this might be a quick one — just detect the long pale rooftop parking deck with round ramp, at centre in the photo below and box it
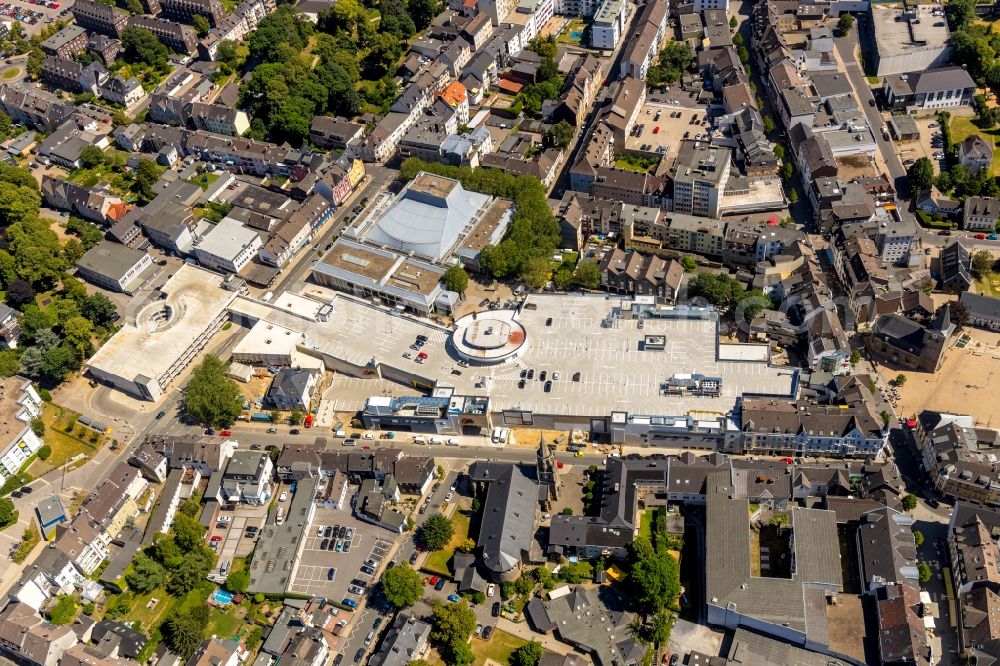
[233,287,795,416]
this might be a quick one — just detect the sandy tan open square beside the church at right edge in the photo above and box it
[879,328,1000,427]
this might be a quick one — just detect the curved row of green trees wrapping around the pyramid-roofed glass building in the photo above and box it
[400,157,560,288]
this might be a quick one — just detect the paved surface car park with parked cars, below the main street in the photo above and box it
[290,507,399,603]
